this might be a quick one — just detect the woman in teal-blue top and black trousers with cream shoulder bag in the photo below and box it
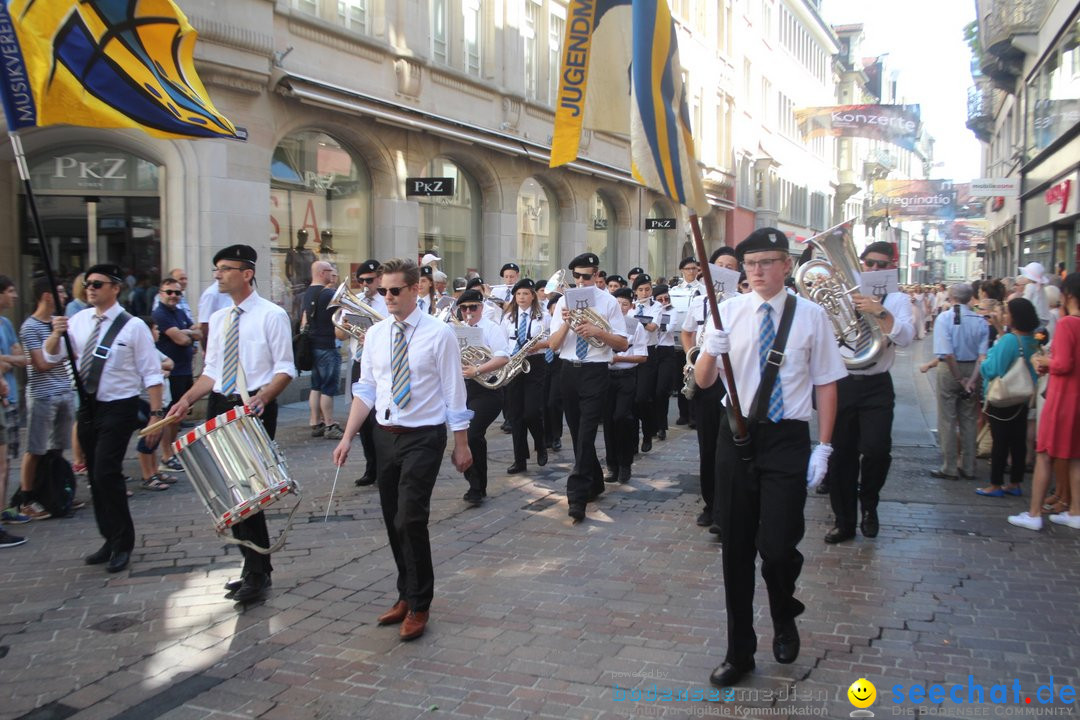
[975,298,1039,498]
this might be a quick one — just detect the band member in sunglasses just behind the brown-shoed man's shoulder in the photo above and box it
[457,290,510,507]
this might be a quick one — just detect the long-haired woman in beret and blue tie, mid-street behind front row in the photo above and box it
[498,279,548,475]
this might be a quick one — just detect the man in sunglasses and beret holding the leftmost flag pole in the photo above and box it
[43,264,165,572]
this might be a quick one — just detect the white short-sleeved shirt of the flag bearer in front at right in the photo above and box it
[716,290,848,421]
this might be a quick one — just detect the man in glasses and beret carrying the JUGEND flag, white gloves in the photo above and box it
[694,228,848,688]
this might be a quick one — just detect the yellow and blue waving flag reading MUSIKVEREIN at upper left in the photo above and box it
[0,0,239,138]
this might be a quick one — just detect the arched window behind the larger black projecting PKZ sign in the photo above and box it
[417,158,483,280]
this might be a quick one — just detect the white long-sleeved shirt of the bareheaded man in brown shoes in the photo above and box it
[352,308,473,431]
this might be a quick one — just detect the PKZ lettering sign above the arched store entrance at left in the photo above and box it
[30,150,158,192]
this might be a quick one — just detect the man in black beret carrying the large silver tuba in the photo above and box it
[825,241,915,544]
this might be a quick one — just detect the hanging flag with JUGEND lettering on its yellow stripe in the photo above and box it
[550,0,710,215]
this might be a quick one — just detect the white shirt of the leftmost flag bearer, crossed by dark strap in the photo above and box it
[42,302,162,403]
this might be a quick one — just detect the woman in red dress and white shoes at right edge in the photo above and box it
[1009,272,1080,530]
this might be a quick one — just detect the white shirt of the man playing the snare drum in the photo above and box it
[203,293,296,393]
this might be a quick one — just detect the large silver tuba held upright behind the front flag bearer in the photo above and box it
[795,220,886,370]
